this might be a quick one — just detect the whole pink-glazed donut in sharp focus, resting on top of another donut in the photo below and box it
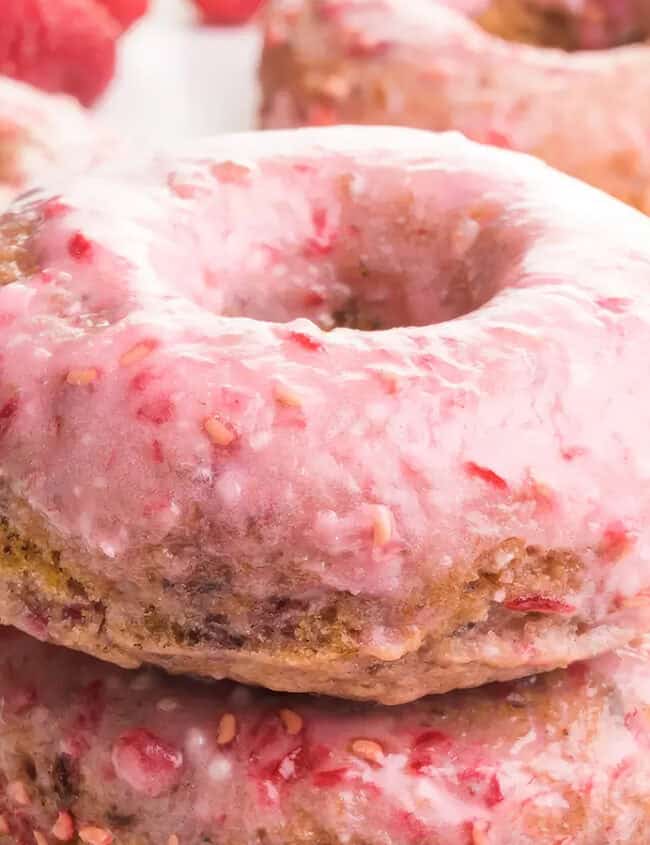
[0,128,650,703]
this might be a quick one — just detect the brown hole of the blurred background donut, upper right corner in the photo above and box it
[475,0,650,52]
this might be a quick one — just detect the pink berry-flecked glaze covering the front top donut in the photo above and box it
[0,128,650,664]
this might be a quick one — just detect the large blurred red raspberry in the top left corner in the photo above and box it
[0,0,119,106]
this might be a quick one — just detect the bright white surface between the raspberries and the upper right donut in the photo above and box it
[96,0,259,141]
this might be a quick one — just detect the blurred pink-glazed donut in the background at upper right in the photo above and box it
[260,0,650,212]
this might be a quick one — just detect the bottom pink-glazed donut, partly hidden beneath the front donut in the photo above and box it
[0,629,650,845]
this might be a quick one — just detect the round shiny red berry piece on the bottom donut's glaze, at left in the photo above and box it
[113,728,183,798]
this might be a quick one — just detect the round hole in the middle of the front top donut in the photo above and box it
[178,162,521,331]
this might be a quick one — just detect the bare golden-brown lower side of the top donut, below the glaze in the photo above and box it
[0,484,635,704]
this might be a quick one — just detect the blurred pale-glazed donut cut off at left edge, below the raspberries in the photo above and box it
[0,76,99,209]
